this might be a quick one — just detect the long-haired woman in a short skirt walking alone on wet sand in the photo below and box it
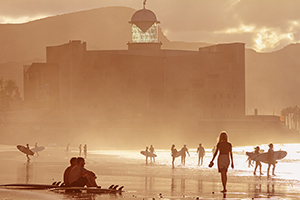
[209,131,234,192]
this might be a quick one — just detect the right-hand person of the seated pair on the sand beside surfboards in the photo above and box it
[69,157,97,187]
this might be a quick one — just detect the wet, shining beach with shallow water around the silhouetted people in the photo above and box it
[0,144,300,200]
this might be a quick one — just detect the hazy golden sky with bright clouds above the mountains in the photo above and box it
[0,0,300,51]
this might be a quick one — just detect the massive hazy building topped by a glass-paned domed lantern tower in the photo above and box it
[24,7,245,142]
